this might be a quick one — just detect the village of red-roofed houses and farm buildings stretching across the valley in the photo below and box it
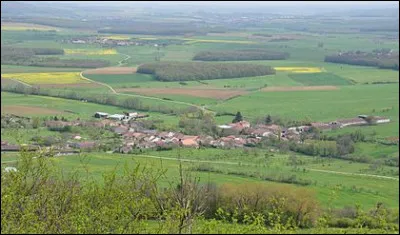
[1,112,390,155]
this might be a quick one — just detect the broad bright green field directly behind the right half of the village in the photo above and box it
[211,84,399,126]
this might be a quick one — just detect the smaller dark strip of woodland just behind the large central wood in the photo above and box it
[193,49,289,61]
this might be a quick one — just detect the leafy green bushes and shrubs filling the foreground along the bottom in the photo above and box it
[1,152,398,234]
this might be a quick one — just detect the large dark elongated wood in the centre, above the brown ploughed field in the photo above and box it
[137,62,275,81]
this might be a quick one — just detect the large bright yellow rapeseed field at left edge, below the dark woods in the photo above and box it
[1,72,89,84]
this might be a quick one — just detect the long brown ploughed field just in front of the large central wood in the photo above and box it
[116,88,246,100]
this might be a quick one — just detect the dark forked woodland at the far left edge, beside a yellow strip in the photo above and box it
[1,47,110,68]
